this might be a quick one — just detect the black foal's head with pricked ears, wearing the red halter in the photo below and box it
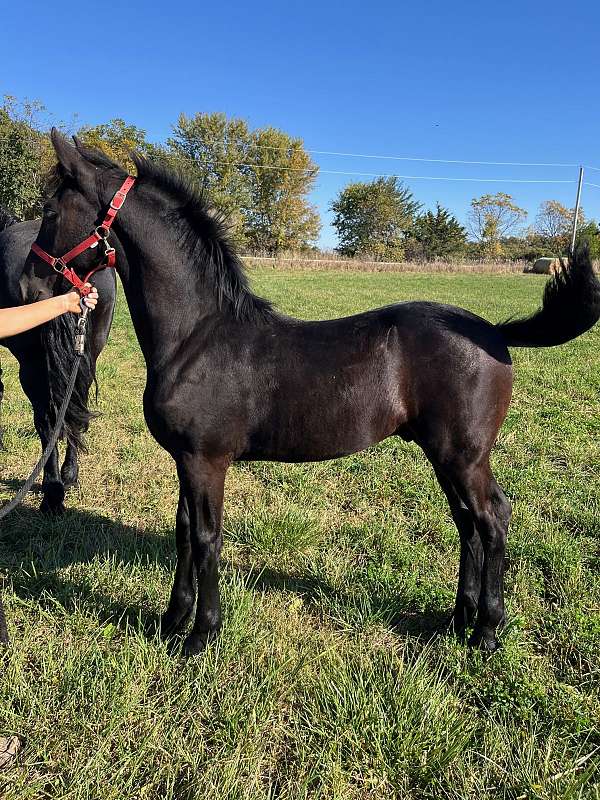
[21,129,127,302]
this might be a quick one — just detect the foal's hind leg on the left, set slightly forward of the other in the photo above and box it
[434,467,483,637]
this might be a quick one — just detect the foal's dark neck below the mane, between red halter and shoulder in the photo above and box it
[112,203,220,368]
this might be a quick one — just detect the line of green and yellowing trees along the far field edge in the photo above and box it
[0,97,600,261]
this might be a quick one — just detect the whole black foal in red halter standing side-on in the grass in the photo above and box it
[27,132,600,654]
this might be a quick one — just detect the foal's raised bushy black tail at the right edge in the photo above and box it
[496,243,600,347]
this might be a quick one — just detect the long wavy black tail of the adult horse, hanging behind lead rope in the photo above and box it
[41,304,98,451]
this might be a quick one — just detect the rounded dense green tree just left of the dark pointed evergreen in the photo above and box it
[331,178,420,261]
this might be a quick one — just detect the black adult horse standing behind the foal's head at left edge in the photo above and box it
[0,207,116,514]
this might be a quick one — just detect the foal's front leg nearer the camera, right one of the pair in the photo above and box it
[178,454,230,655]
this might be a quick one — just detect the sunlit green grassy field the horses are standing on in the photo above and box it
[0,269,600,800]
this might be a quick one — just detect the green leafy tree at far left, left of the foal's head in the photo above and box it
[0,96,53,219]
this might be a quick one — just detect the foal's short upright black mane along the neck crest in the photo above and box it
[133,154,274,321]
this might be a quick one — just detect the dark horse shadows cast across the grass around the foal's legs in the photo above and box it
[0,508,448,639]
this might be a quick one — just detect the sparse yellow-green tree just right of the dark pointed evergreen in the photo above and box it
[468,192,527,258]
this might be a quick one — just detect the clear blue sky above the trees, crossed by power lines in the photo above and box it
[0,0,600,246]
